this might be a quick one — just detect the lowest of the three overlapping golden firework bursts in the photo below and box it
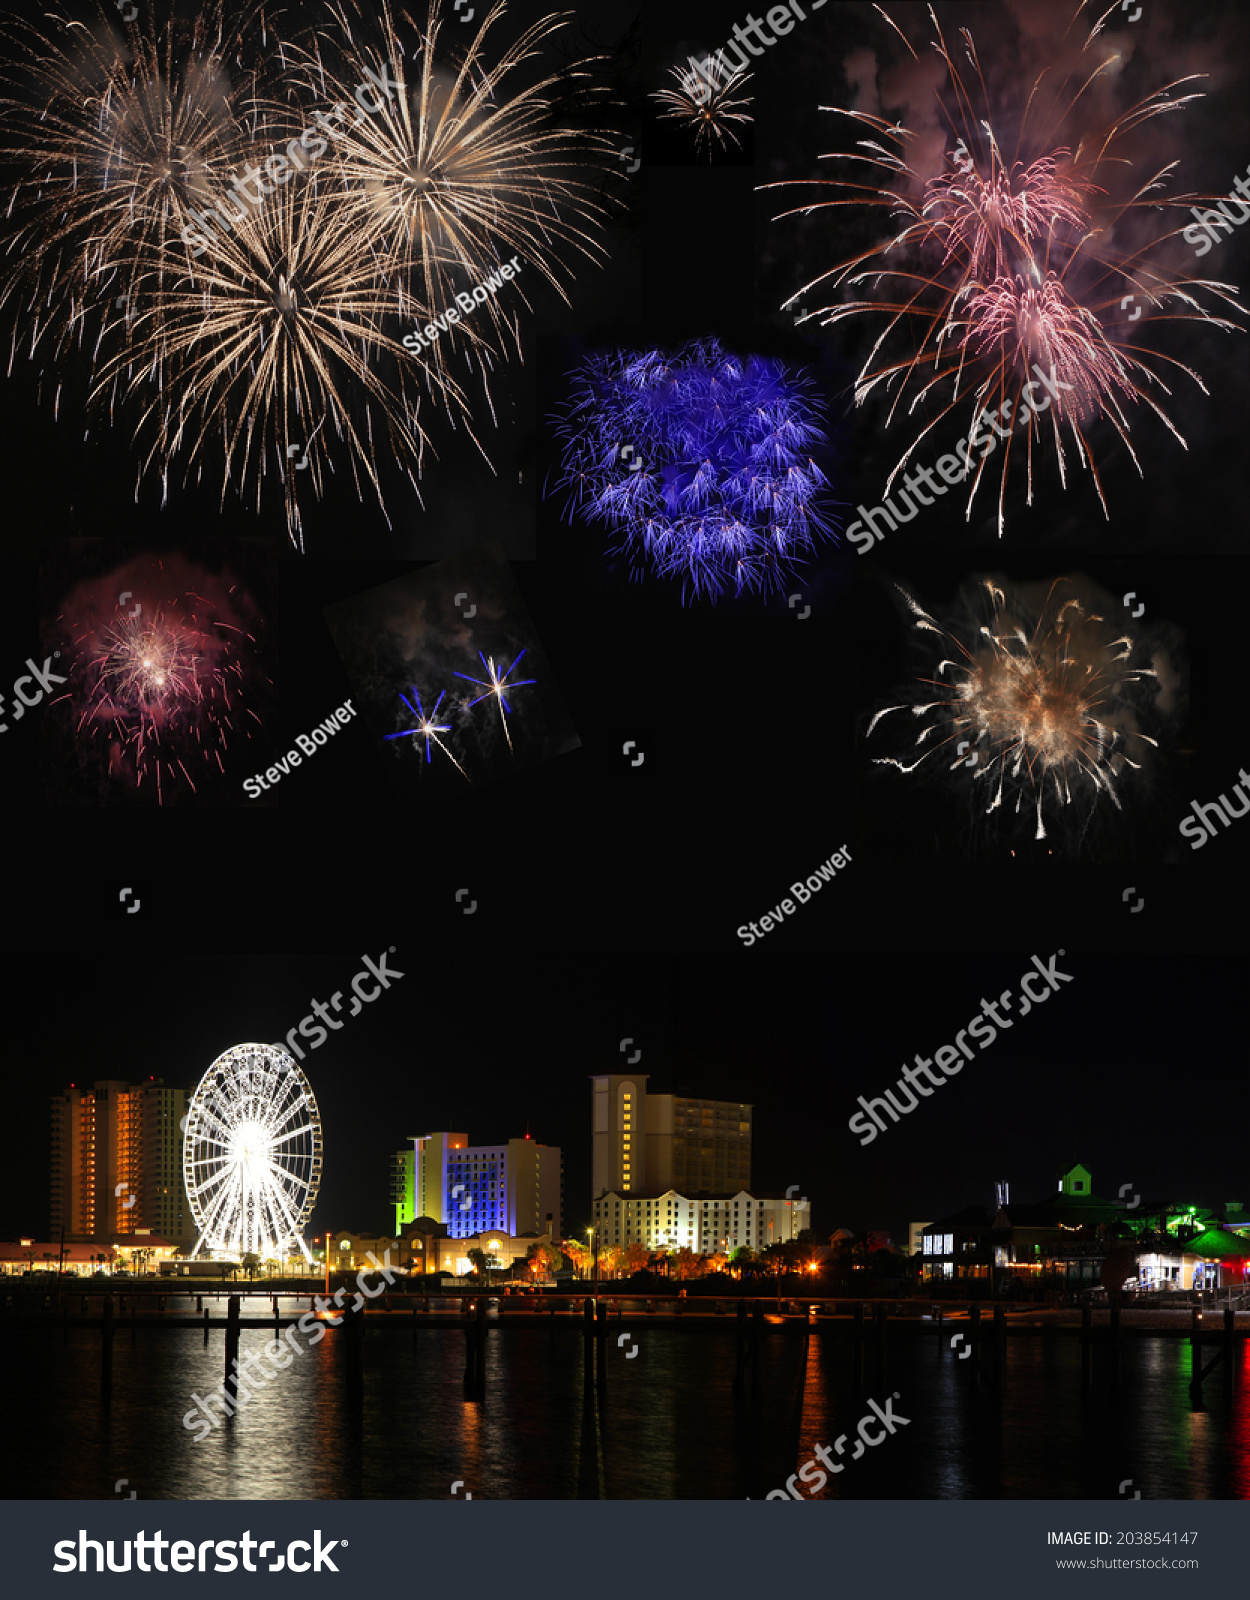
[94,164,438,549]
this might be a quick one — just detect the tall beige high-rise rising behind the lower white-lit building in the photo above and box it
[591,1072,751,1198]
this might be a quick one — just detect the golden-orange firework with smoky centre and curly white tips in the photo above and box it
[866,578,1159,838]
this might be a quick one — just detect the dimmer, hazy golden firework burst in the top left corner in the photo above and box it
[0,0,262,377]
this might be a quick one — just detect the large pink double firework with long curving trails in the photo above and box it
[763,0,1242,536]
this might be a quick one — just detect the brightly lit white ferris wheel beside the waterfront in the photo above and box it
[182,1045,322,1261]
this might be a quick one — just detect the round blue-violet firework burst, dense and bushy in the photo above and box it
[555,339,832,598]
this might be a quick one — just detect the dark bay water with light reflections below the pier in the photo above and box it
[3,1315,1250,1499]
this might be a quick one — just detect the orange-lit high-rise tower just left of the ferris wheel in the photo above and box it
[51,1078,194,1243]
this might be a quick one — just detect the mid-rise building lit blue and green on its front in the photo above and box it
[391,1133,563,1238]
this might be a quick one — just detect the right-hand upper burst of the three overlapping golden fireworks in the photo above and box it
[272,0,619,373]
